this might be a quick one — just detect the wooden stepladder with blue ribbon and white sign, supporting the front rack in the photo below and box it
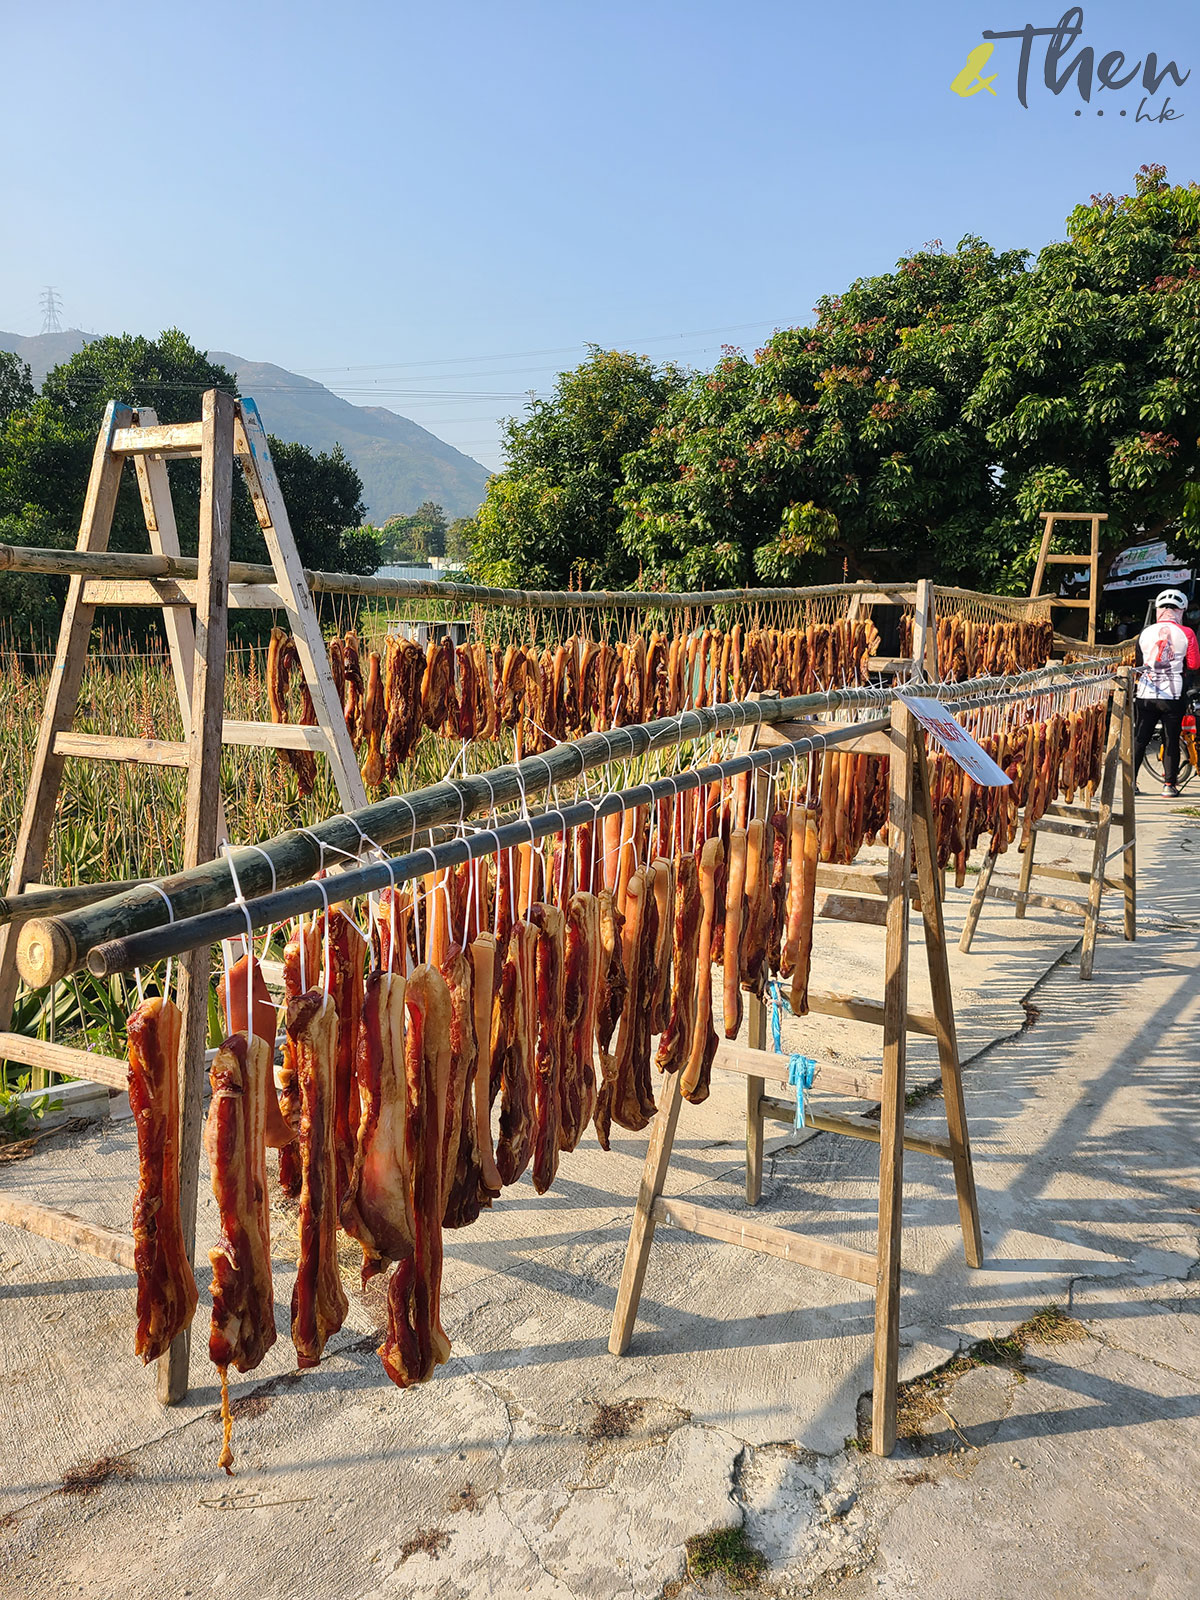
[608,701,982,1456]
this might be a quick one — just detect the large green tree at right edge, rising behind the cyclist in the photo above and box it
[963,166,1200,587]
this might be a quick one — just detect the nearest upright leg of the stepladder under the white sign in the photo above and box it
[870,701,923,1456]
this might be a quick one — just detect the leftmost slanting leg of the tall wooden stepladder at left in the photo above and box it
[0,400,133,1027]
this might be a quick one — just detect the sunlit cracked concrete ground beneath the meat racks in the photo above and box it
[0,798,1200,1600]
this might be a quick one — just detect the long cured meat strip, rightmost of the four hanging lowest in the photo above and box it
[379,965,451,1389]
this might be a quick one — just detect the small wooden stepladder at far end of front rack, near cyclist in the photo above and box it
[958,667,1138,979]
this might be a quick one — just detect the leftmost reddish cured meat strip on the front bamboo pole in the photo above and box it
[126,995,198,1362]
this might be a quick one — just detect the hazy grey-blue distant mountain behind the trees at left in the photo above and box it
[0,328,491,523]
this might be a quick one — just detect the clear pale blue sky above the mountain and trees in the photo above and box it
[0,0,1200,467]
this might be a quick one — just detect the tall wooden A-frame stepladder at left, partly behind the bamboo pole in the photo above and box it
[0,389,366,1403]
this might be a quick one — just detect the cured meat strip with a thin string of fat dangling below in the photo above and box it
[205,1034,275,1472]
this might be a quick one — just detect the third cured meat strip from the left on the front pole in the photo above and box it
[286,989,349,1368]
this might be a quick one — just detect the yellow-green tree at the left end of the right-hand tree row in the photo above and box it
[469,346,686,589]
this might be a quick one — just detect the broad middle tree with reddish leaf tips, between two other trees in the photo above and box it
[618,238,1024,589]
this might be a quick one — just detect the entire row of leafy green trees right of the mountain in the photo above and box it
[470,166,1200,589]
